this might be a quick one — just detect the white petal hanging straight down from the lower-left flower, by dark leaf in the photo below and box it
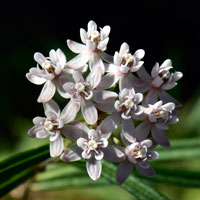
[50,136,64,157]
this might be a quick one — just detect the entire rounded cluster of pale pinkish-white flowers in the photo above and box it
[26,21,183,184]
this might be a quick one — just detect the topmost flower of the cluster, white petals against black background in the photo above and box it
[67,20,112,74]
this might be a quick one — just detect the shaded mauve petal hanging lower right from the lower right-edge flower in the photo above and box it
[151,127,170,147]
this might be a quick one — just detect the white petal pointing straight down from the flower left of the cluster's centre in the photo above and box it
[81,100,98,124]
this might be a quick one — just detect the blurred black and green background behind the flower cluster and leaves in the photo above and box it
[0,0,200,200]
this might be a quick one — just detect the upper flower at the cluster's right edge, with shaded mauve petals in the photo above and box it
[133,59,183,106]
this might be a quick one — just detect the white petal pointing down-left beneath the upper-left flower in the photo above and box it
[37,81,56,103]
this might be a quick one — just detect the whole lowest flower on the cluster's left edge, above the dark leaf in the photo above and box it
[28,100,77,157]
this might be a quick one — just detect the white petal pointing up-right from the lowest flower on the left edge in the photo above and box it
[60,101,80,124]
